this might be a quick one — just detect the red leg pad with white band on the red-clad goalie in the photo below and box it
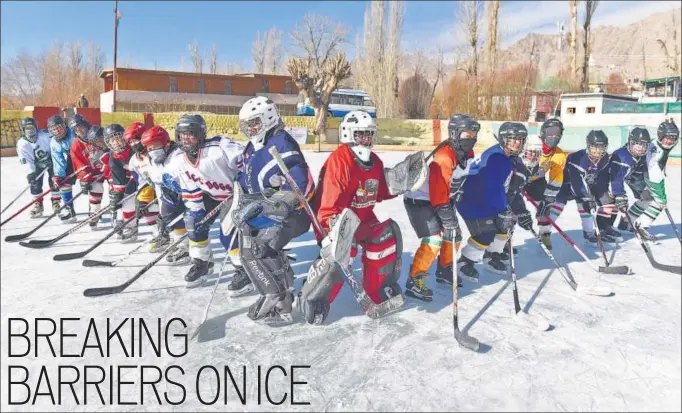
[358,219,403,304]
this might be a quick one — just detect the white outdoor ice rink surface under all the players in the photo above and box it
[0,152,682,411]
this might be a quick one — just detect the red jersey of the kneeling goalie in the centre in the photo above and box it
[313,145,395,240]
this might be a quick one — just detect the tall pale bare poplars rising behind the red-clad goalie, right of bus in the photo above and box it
[356,1,402,118]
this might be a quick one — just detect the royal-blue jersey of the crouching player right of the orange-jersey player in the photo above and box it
[457,145,512,221]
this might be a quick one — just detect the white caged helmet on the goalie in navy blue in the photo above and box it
[239,96,282,150]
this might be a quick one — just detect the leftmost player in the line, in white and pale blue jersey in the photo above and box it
[17,118,60,218]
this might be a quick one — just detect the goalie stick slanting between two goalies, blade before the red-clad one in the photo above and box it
[268,146,404,318]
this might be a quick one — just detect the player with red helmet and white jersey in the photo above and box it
[137,126,190,265]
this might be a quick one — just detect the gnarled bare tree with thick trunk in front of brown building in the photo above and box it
[287,13,351,140]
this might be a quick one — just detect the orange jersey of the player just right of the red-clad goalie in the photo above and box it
[405,145,474,207]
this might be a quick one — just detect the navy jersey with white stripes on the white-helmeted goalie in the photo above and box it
[238,130,315,198]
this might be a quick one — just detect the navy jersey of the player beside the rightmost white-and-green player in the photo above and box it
[609,145,656,196]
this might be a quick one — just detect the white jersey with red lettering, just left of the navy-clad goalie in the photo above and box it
[171,136,244,210]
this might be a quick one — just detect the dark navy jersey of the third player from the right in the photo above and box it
[562,149,610,199]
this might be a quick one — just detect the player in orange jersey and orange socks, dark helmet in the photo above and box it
[403,114,481,301]
